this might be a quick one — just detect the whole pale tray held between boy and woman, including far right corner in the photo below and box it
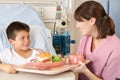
[15,60,90,75]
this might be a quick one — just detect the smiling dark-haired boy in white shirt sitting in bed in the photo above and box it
[0,21,39,73]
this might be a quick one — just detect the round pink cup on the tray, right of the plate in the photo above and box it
[68,54,85,64]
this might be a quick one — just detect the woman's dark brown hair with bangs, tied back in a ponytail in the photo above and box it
[74,1,115,38]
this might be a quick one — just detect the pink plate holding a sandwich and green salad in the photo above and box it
[19,52,66,70]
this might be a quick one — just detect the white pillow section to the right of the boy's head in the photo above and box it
[30,25,56,54]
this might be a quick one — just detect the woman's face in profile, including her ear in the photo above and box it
[76,19,95,35]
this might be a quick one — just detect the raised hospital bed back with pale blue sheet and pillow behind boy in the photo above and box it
[0,4,55,54]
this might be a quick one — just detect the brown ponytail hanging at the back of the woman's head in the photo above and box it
[96,15,115,38]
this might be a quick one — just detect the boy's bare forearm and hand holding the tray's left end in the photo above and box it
[0,60,17,73]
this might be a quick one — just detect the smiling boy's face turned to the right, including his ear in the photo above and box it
[9,30,30,51]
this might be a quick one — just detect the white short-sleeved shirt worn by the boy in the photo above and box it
[0,48,39,65]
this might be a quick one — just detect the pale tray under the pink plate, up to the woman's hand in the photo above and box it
[15,64,78,75]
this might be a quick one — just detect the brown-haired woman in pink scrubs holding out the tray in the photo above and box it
[73,1,120,80]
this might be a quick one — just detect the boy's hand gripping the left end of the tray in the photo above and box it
[3,64,18,74]
